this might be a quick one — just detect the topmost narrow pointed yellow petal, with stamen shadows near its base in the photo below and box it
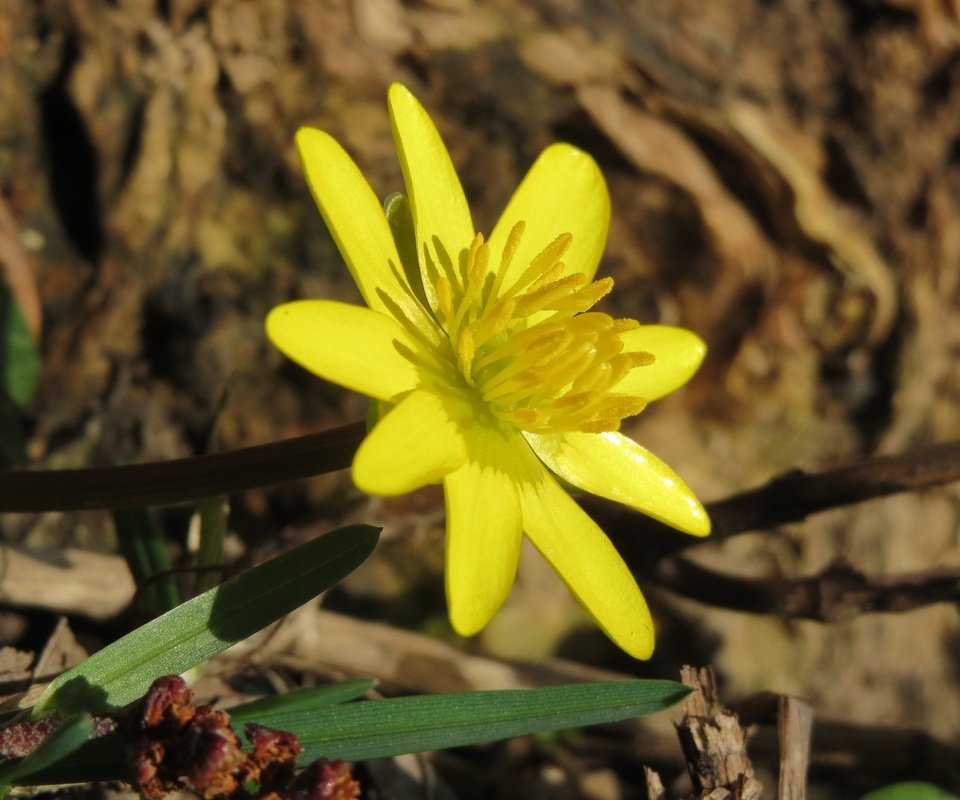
[387,83,474,308]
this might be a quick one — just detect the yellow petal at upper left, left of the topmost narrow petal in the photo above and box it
[297,128,429,329]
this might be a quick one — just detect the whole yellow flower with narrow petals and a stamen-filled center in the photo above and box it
[267,84,710,658]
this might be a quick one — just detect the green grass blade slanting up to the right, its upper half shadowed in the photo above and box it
[33,525,379,717]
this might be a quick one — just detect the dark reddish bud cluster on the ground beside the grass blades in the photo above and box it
[130,675,360,800]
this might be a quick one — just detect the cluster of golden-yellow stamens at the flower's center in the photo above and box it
[428,221,654,433]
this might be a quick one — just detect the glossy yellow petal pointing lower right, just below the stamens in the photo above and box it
[524,432,710,536]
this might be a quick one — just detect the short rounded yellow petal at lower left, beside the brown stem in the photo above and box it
[353,388,467,495]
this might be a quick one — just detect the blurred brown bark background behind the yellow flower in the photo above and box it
[0,0,960,768]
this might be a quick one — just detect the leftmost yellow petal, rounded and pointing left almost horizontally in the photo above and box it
[266,300,420,400]
